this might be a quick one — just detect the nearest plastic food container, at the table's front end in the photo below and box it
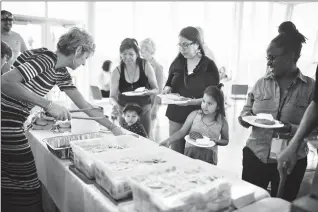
[129,168,231,212]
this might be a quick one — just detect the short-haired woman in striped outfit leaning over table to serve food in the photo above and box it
[1,28,123,212]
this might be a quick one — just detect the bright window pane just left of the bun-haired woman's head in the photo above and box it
[236,2,287,86]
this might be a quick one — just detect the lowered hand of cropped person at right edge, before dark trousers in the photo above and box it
[277,139,297,176]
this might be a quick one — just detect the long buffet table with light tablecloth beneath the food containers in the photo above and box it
[27,130,284,212]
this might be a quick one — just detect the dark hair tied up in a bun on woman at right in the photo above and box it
[272,21,307,62]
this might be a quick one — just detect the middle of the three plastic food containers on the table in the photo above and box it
[95,147,186,200]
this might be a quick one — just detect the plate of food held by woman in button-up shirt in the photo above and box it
[242,113,284,129]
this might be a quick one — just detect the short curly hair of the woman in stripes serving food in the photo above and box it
[57,27,95,56]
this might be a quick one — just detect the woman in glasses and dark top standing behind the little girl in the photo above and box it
[163,26,220,154]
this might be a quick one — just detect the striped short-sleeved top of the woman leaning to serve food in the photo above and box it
[1,48,76,112]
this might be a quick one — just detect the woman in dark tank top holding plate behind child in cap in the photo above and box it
[110,38,159,135]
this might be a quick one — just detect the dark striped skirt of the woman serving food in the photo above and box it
[1,104,43,212]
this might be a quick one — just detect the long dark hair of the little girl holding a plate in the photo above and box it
[204,83,225,121]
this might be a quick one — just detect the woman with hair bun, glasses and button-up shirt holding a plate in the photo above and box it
[239,22,315,201]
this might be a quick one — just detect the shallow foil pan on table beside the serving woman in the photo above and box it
[43,133,105,160]
